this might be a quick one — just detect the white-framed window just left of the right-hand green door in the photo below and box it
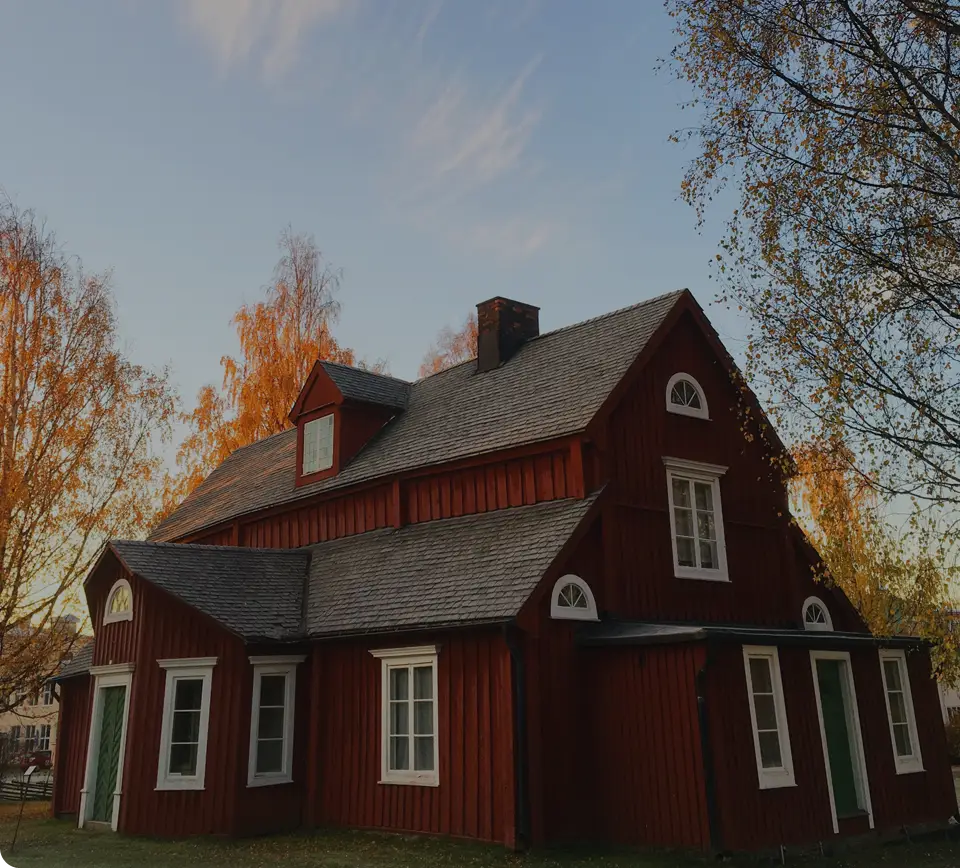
[743,645,796,790]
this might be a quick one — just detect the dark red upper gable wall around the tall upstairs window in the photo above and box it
[602,316,862,629]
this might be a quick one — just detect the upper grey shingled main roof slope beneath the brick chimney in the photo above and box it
[150,291,684,541]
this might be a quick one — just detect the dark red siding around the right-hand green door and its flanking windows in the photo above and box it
[708,645,956,850]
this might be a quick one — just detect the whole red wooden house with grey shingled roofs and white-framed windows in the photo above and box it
[54,292,957,851]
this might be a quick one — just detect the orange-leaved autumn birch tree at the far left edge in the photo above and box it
[0,200,175,711]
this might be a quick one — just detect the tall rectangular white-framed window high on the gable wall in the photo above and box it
[663,458,728,582]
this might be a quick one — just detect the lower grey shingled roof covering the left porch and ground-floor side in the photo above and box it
[101,494,599,642]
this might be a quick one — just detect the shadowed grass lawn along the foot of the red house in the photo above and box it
[0,805,960,868]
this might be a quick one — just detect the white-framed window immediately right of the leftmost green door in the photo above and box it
[157,657,217,790]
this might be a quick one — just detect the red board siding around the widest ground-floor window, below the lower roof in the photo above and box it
[313,631,515,846]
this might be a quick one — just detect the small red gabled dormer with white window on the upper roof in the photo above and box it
[289,361,410,486]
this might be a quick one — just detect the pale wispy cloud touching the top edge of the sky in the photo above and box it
[181,0,356,79]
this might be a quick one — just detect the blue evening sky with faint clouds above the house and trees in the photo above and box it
[0,0,742,430]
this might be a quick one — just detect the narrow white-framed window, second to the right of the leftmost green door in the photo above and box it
[247,654,306,787]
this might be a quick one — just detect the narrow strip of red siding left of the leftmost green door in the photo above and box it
[51,675,93,817]
